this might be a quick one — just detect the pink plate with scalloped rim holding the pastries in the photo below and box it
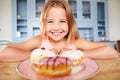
[17,59,99,80]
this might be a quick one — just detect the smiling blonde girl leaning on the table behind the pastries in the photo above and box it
[0,0,118,62]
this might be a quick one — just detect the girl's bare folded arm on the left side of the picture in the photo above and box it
[0,36,41,62]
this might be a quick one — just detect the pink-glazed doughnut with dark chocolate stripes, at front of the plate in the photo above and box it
[33,56,73,78]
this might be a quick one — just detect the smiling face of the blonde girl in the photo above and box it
[45,7,68,41]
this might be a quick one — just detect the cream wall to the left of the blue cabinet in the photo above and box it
[0,0,12,41]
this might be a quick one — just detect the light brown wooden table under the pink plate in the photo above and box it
[0,53,120,80]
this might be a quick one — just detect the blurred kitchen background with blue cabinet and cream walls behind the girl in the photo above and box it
[0,0,120,50]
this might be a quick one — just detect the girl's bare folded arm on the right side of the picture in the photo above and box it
[76,39,118,59]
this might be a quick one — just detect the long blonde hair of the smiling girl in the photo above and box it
[40,0,79,43]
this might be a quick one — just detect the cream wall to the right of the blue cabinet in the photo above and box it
[108,0,120,41]
